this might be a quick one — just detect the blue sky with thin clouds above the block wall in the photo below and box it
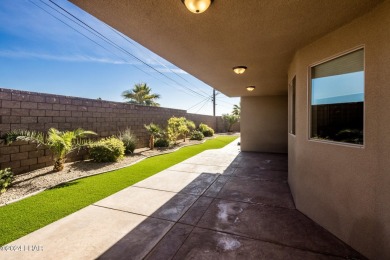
[0,0,239,115]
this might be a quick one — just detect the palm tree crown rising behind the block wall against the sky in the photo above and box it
[122,83,160,107]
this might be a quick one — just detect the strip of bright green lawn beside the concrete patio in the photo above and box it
[0,136,237,246]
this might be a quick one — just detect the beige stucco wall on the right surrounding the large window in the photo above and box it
[288,1,390,259]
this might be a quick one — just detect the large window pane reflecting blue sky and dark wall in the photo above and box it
[310,49,364,144]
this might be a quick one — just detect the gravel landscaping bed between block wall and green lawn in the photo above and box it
[0,140,204,206]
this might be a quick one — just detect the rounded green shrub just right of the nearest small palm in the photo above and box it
[89,137,125,162]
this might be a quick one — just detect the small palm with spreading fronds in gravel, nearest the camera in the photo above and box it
[12,128,96,172]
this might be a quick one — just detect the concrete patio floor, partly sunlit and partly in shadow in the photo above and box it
[0,141,364,259]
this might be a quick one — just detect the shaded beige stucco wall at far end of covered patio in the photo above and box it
[240,96,288,153]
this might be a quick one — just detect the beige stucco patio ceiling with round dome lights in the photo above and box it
[70,0,382,96]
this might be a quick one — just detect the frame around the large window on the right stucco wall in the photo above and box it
[307,45,367,148]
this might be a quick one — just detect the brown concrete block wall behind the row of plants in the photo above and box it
[0,88,227,173]
